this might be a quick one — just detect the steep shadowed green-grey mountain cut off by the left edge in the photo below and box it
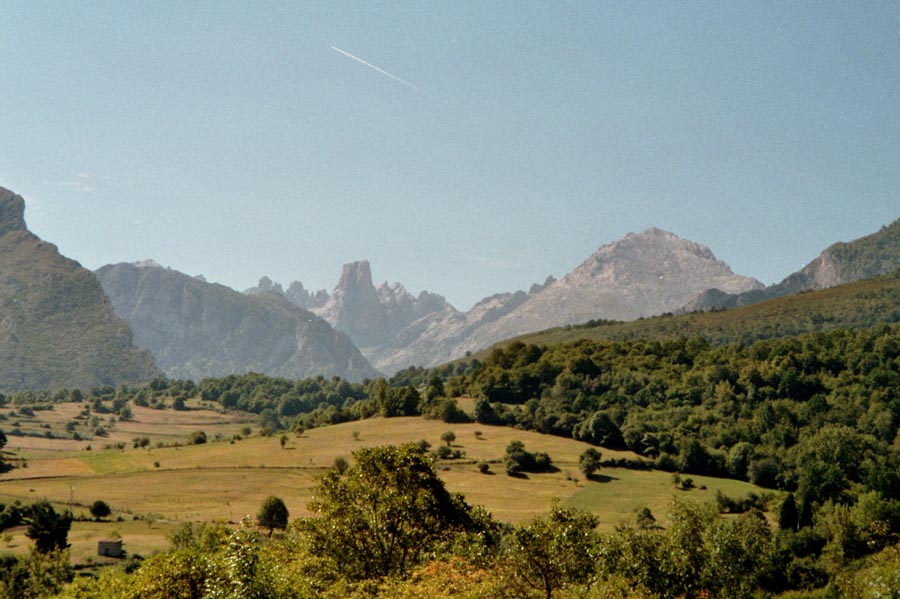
[0,187,161,391]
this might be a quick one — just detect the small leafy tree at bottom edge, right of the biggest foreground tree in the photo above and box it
[503,505,599,599]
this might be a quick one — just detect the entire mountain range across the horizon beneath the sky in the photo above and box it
[0,182,900,391]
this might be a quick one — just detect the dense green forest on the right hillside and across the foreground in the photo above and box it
[2,325,900,597]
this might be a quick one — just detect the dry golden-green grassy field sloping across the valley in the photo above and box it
[0,404,772,563]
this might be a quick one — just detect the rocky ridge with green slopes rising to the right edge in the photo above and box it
[679,219,900,313]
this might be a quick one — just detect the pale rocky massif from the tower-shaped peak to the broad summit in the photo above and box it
[270,229,763,373]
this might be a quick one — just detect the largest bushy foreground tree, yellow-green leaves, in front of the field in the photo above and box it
[298,444,486,580]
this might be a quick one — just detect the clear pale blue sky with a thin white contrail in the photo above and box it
[0,0,900,309]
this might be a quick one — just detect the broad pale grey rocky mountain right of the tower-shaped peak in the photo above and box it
[370,228,762,372]
